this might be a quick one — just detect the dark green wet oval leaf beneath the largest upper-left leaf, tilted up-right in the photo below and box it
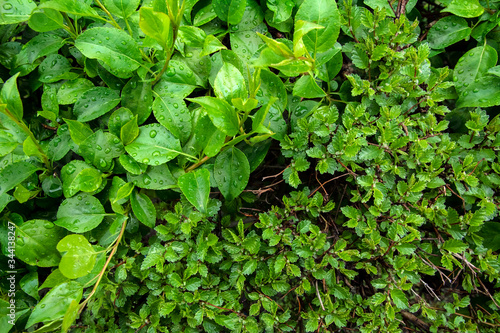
[73,87,120,122]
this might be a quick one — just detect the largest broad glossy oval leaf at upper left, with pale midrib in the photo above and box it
[75,27,142,78]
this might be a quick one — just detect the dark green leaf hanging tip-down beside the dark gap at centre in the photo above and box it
[214,147,250,201]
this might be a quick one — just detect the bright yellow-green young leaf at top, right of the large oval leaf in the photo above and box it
[139,7,174,52]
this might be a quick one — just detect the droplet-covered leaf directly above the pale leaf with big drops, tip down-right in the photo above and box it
[153,94,192,142]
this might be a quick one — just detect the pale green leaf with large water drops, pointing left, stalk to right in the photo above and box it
[125,124,182,165]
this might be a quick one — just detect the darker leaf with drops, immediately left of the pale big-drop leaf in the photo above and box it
[78,130,125,171]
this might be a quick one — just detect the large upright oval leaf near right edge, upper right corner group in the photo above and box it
[453,45,498,92]
